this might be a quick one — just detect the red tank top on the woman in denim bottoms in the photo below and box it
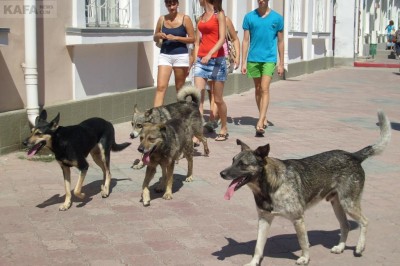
[197,14,225,58]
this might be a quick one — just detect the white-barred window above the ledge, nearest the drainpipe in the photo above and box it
[85,0,130,27]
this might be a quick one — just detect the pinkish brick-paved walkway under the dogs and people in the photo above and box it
[0,65,400,266]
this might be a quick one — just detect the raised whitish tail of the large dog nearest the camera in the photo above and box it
[354,110,391,161]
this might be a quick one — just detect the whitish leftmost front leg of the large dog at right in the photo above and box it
[245,214,274,266]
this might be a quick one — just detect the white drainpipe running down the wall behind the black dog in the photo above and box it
[23,0,39,125]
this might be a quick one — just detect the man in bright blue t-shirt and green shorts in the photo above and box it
[242,0,285,135]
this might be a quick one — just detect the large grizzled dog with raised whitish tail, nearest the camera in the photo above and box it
[220,112,391,266]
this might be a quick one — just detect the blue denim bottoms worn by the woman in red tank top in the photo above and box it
[194,56,228,81]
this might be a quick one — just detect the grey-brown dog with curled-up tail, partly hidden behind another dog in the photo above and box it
[130,86,210,169]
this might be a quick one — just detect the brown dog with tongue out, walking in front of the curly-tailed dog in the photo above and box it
[138,119,193,206]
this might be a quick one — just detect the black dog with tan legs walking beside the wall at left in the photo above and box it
[23,110,131,211]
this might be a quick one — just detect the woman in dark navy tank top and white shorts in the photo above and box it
[153,0,195,107]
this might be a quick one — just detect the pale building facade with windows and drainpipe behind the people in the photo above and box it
[0,0,392,154]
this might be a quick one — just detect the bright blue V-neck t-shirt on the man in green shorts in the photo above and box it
[242,9,283,63]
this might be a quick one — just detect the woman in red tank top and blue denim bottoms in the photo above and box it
[194,0,229,141]
